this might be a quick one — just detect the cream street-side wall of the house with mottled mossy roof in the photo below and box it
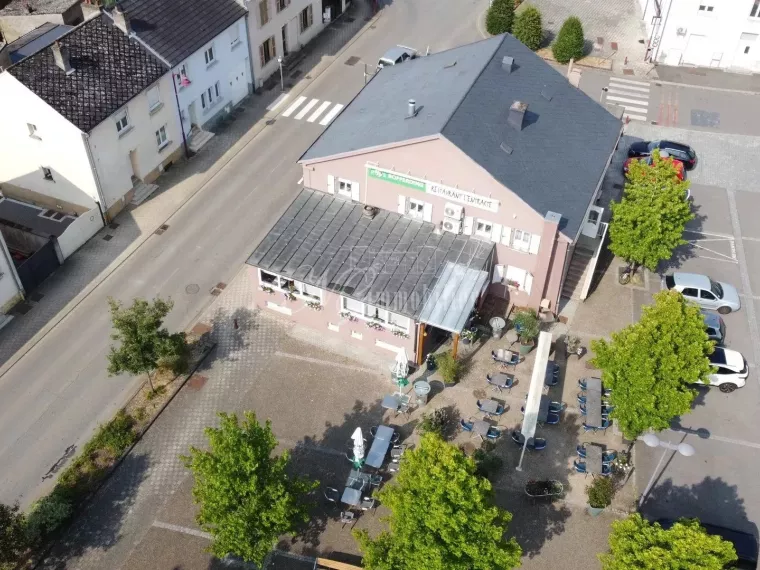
[89,72,182,211]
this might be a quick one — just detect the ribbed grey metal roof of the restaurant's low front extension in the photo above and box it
[247,189,493,318]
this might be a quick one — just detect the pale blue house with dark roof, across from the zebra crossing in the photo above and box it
[106,0,253,151]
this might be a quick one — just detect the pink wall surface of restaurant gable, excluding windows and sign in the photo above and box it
[303,138,567,307]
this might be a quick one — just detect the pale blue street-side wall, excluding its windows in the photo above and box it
[172,18,253,133]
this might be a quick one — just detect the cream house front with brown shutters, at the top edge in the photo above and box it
[243,0,324,89]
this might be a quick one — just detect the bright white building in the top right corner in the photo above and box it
[639,0,760,72]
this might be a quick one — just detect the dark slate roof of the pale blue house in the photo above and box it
[111,0,246,66]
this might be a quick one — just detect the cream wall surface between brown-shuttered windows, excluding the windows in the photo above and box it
[246,0,325,89]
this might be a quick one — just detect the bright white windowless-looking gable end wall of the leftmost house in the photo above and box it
[0,71,98,210]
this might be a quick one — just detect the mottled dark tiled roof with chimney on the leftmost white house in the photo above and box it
[7,14,168,132]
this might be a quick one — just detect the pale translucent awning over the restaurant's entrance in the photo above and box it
[418,261,488,334]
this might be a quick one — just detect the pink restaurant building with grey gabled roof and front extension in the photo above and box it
[248,35,622,359]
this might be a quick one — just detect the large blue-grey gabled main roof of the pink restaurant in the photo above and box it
[301,34,622,238]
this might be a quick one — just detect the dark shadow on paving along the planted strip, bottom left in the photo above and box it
[39,453,150,570]
